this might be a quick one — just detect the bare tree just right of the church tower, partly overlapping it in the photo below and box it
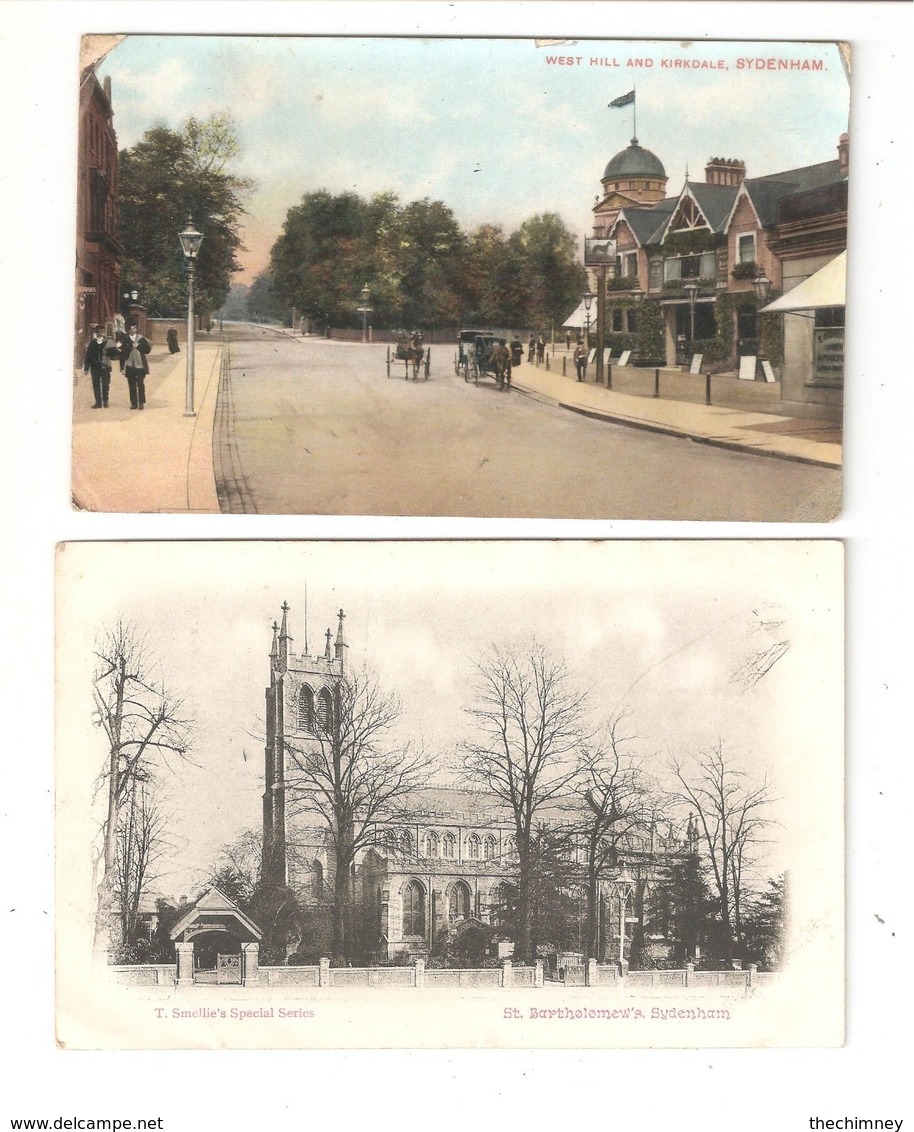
[285,672,429,960]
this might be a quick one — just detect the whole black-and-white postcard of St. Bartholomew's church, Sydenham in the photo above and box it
[55,540,845,1049]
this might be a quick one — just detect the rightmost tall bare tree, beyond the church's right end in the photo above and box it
[672,741,774,959]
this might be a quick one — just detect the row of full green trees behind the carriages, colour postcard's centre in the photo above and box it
[260,190,586,328]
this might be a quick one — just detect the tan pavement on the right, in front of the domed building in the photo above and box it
[512,351,842,468]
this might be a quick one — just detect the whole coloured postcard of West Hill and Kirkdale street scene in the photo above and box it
[71,35,851,522]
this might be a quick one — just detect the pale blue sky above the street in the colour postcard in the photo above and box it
[99,35,849,282]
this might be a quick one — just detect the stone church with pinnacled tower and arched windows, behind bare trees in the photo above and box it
[262,603,694,961]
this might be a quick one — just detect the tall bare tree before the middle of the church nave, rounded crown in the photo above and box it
[460,641,590,962]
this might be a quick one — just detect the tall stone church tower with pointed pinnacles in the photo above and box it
[262,602,349,887]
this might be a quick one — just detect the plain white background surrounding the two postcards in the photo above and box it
[0,0,914,1132]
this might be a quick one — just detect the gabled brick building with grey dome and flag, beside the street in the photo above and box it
[592,135,848,406]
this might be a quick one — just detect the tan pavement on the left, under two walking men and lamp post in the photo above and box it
[71,335,222,514]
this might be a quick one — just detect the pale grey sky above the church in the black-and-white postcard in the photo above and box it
[59,541,840,895]
